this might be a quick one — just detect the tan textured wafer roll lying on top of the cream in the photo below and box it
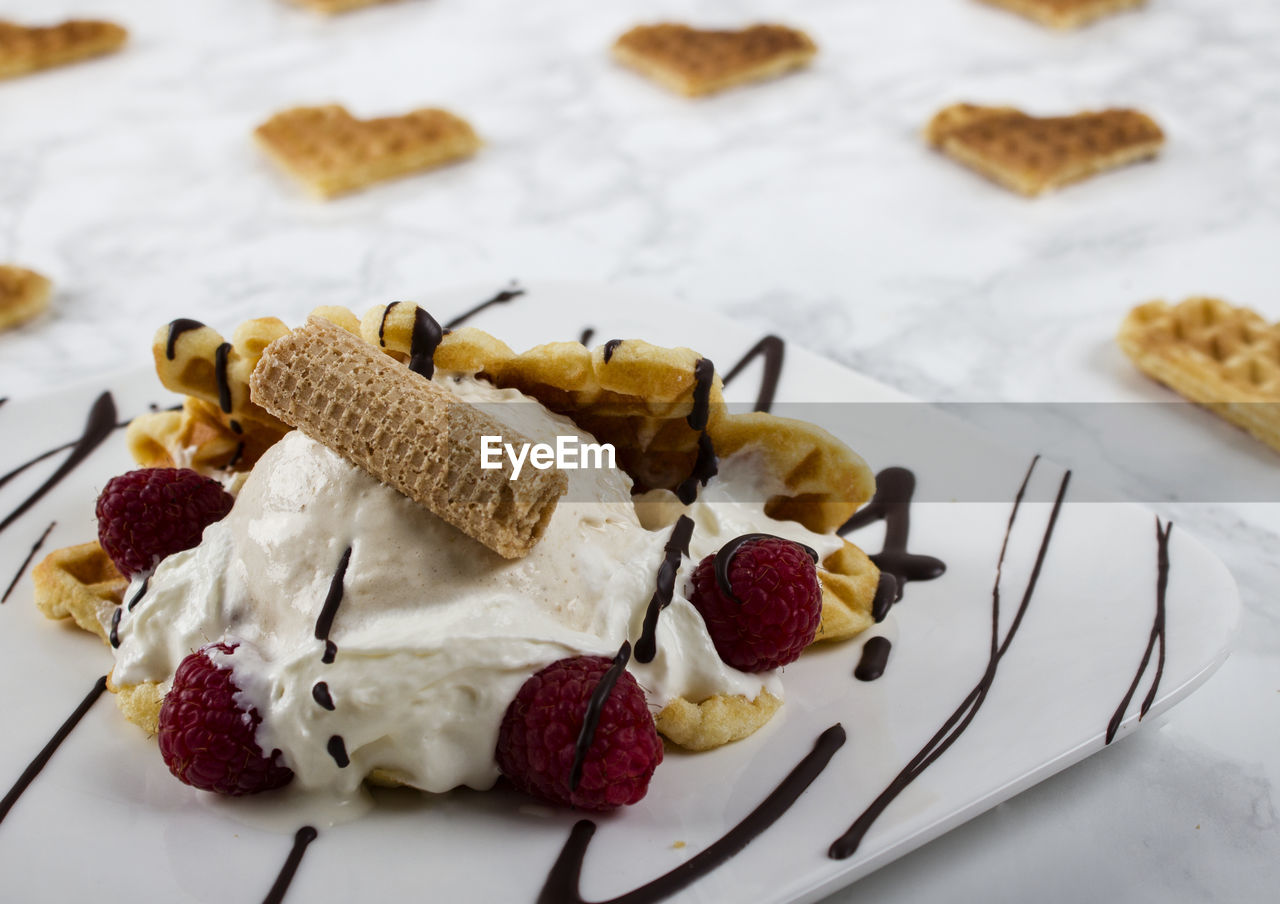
[250,318,568,558]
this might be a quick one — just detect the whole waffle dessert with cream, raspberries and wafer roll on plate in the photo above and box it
[36,303,881,808]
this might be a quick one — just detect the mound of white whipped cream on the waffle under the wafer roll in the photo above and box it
[113,375,841,796]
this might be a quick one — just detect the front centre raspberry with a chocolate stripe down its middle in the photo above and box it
[497,647,662,811]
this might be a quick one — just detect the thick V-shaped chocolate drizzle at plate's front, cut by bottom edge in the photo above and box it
[538,723,845,904]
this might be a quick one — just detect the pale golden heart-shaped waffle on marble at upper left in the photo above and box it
[253,104,480,197]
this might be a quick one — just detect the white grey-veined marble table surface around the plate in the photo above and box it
[0,0,1280,903]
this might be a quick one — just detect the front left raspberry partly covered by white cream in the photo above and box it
[160,644,293,796]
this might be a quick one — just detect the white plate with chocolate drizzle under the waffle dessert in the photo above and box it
[0,283,1239,904]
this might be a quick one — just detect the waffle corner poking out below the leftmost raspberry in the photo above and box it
[31,542,129,643]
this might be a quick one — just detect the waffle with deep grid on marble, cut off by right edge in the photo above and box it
[1117,298,1280,451]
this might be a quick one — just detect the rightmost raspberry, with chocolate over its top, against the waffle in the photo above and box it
[689,535,822,672]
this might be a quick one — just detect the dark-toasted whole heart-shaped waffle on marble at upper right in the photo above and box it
[925,104,1165,196]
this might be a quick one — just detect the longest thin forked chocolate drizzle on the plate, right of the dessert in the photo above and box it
[827,456,1071,860]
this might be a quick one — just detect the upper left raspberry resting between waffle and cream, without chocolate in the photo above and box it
[97,467,234,577]
